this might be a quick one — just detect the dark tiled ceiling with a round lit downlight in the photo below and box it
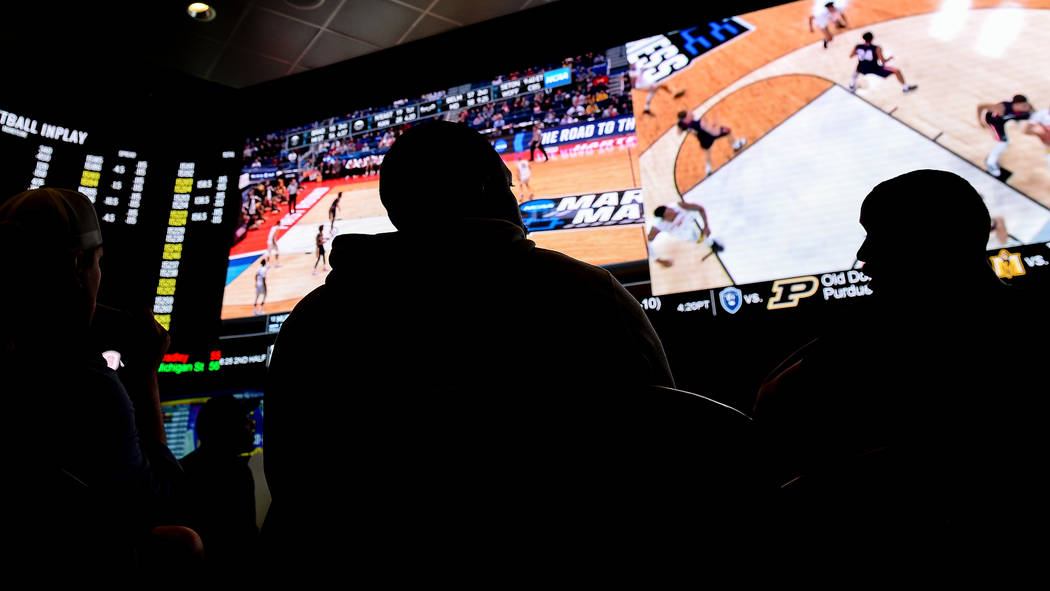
[2,0,554,88]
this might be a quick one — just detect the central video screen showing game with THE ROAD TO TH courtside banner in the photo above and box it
[222,46,648,321]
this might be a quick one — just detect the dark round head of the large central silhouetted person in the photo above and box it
[379,121,525,231]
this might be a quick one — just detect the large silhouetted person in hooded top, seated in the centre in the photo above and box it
[263,122,688,572]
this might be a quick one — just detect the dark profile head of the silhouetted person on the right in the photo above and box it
[857,170,993,295]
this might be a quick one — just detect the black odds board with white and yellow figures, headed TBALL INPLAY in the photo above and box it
[0,102,237,346]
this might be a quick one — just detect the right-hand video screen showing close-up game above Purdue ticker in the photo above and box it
[627,0,1050,315]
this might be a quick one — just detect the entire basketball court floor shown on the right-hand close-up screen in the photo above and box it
[634,0,1050,293]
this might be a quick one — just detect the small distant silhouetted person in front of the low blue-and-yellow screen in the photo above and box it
[181,395,258,573]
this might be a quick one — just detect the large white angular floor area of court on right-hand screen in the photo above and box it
[653,86,1050,295]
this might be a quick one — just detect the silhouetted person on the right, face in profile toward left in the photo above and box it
[754,170,1040,551]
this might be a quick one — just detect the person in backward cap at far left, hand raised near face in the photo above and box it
[0,188,183,569]
